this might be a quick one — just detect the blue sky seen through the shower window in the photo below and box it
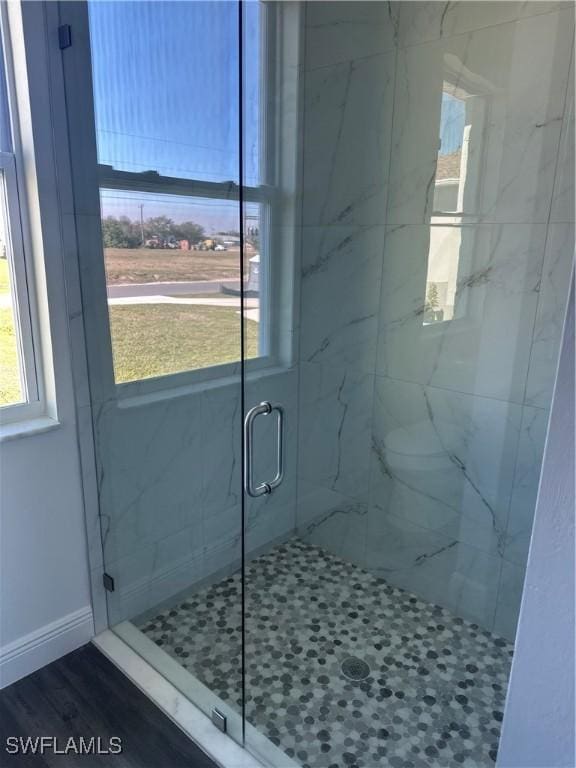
[89,0,260,232]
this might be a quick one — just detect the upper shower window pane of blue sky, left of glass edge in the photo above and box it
[89,2,238,181]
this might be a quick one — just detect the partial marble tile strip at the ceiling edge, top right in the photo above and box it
[398,0,571,45]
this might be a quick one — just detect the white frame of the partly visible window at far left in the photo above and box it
[0,16,46,425]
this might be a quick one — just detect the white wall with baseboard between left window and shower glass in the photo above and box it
[0,3,93,686]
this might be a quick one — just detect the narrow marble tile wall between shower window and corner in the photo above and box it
[297,2,399,528]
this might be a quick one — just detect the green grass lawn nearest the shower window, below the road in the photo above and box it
[110,304,258,383]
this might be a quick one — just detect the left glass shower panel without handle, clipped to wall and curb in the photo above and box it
[72,1,252,742]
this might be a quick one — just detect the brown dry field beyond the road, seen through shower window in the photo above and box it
[104,248,254,285]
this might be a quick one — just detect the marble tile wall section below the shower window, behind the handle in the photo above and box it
[95,369,297,625]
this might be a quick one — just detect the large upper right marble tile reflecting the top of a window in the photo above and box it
[387,10,574,224]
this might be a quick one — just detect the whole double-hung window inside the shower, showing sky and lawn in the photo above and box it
[89,1,273,384]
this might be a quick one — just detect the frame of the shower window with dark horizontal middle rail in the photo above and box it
[97,0,282,399]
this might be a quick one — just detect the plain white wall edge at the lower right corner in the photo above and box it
[498,272,576,768]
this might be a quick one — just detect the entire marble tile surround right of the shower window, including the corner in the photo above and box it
[297,2,574,639]
